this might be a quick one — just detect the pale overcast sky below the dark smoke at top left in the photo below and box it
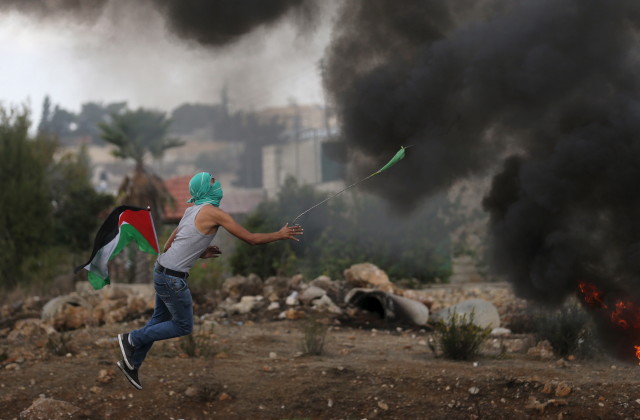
[0,2,330,122]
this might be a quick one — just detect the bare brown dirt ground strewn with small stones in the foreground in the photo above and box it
[0,318,640,419]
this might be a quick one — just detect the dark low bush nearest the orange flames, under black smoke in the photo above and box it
[535,303,596,357]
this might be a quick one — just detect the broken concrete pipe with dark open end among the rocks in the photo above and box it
[345,288,429,325]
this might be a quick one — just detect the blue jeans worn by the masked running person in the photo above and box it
[129,270,193,369]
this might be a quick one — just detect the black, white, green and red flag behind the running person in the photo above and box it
[75,206,158,289]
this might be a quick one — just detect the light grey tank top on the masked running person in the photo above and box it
[158,203,216,272]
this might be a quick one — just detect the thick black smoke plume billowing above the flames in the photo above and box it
[324,0,640,354]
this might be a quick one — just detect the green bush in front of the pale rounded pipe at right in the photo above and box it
[435,312,491,360]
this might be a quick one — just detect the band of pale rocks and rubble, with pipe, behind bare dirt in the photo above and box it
[0,263,528,360]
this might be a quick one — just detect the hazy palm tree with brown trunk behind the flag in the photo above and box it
[99,108,184,281]
